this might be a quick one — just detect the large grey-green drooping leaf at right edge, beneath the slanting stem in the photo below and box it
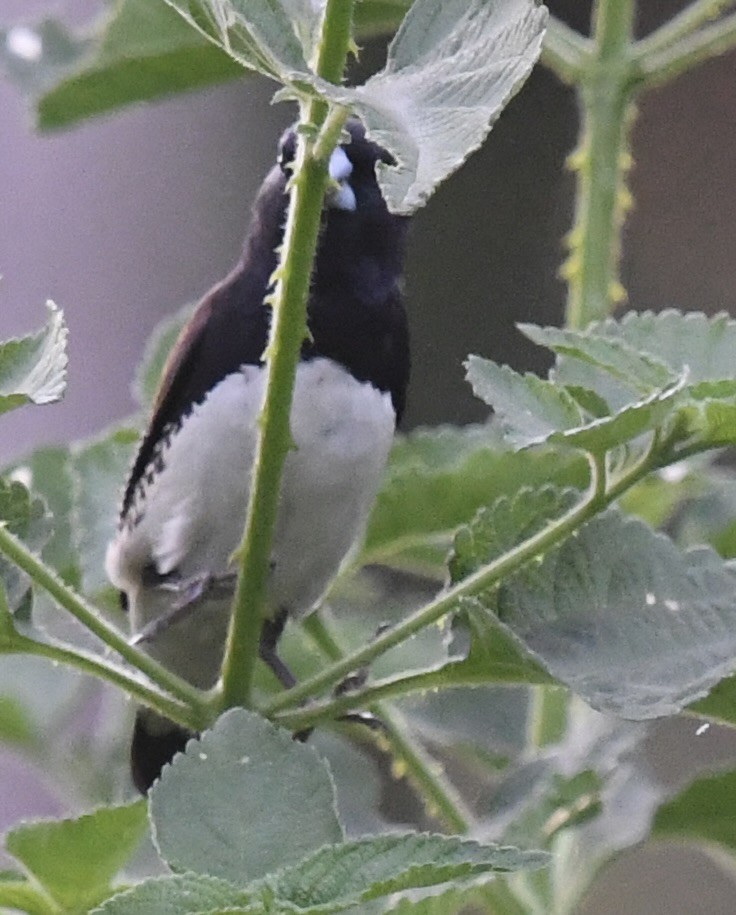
[478,511,736,719]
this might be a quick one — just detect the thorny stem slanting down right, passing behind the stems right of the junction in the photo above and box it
[304,613,472,834]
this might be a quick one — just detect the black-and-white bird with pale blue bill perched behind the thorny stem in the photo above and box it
[105,118,410,794]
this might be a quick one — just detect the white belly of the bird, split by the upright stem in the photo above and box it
[106,359,395,686]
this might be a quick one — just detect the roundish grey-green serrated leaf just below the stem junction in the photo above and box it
[150,709,342,885]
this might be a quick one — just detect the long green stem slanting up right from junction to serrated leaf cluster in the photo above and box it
[261,460,600,715]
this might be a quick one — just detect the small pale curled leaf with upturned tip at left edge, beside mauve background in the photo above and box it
[0,302,67,413]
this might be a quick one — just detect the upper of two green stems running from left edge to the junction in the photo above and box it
[0,524,206,717]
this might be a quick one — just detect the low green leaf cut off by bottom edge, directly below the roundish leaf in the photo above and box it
[92,872,256,915]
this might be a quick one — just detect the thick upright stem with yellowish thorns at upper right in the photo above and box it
[562,0,635,328]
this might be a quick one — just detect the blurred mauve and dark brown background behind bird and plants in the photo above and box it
[0,0,736,915]
